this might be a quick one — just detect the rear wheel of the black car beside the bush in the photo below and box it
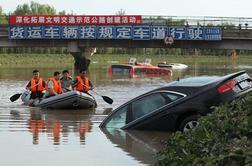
[179,115,199,132]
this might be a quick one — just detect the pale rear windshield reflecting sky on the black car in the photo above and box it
[169,76,221,86]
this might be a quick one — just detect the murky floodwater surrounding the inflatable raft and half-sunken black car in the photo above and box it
[0,58,252,166]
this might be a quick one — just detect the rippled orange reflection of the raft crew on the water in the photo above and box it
[23,109,94,145]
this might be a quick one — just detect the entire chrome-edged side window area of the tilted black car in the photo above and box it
[100,91,184,129]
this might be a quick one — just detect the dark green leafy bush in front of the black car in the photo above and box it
[157,93,252,166]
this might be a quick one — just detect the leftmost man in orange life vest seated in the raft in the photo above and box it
[26,70,46,99]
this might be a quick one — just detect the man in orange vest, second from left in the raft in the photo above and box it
[45,71,62,98]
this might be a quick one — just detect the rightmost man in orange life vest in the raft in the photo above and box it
[73,69,94,93]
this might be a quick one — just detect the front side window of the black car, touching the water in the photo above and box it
[106,106,128,128]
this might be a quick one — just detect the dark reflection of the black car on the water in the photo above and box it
[101,129,170,165]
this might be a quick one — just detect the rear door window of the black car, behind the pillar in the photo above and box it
[132,93,168,120]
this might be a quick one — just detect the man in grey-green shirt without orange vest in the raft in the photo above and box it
[60,70,73,92]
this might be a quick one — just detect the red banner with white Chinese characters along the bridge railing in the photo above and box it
[9,15,142,25]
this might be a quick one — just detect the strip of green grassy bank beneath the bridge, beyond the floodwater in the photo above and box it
[0,54,252,68]
